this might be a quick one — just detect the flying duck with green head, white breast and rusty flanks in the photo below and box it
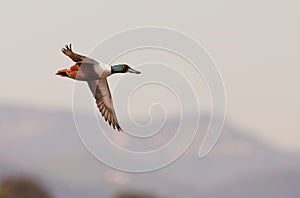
[56,44,141,131]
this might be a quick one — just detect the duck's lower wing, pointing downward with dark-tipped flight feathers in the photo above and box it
[87,78,122,131]
